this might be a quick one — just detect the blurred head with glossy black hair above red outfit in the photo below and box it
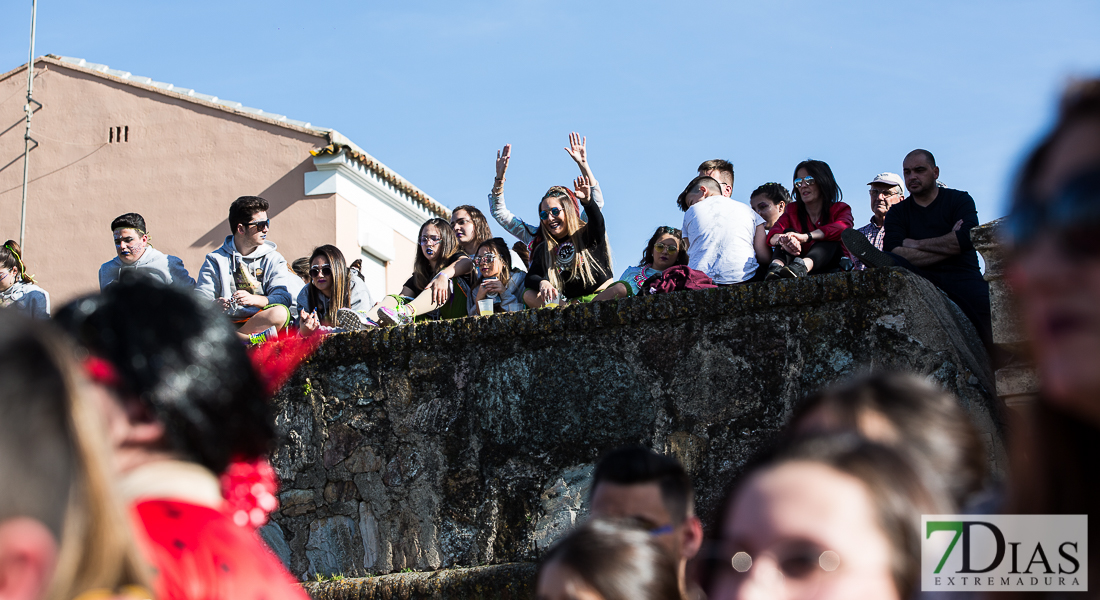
[56,276,274,473]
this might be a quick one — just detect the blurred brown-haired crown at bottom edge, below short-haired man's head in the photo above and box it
[536,519,683,600]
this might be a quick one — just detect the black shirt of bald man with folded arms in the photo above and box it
[882,187,981,276]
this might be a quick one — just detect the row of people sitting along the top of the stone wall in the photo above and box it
[0,126,992,348]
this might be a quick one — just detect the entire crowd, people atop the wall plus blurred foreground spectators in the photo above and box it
[0,80,1100,600]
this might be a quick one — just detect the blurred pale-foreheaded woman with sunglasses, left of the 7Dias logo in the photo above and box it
[702,435,947,600]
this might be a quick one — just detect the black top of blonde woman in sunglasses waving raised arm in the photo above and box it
[524,201,612,298]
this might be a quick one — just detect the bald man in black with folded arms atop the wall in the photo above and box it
[845,149,993,350]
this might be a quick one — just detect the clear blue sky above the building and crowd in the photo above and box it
[0,0,1100,270]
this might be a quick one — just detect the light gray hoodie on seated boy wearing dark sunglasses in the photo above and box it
[196,236,301,319]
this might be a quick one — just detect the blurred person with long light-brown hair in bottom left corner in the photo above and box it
[0,312,150,600]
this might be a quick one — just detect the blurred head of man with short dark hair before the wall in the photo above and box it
[589,446,703,591]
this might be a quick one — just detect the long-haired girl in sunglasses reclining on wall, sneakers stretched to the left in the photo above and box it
[338,218,476,331]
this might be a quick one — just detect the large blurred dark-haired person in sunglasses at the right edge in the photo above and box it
[998,79,1100,598]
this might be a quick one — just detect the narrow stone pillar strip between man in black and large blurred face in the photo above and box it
[970,219,1040,406]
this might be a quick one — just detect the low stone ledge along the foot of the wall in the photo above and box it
[305,563,536,600]
